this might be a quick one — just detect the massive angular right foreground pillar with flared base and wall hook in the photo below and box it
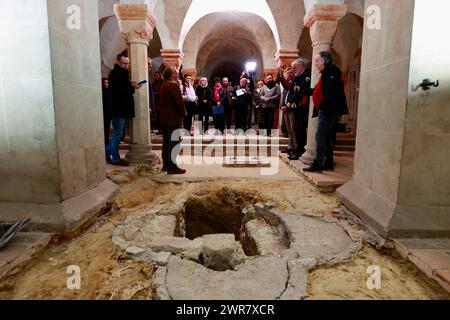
[338,0,450,237]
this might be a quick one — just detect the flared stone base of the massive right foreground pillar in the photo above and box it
[336,180,450,239]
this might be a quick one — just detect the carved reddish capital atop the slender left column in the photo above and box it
[114,4,156,46]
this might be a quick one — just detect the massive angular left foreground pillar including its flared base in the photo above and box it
[0,0,118,234]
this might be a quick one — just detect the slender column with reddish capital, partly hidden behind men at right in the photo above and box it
[301,4,347,164]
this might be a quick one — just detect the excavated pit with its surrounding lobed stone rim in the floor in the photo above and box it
[112,194,363,300]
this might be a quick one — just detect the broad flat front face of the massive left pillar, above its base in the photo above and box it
[0,0,61,203]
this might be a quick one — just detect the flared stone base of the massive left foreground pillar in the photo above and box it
[0,180,119,237]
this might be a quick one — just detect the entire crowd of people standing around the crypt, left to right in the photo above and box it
[103,52,348,174]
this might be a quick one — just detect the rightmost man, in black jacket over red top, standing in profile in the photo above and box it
[303,51,348,172]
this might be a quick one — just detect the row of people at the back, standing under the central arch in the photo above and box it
[169,72,281,138]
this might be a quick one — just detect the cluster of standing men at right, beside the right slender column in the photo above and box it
[278,51,348,173]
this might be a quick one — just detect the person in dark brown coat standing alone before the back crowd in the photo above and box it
[159,67,187,174]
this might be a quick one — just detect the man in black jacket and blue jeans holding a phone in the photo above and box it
[106,53,141,166]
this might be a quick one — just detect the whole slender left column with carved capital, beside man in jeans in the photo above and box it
[114,4,156,163]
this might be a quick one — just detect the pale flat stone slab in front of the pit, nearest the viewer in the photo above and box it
[166,256,288,300]
